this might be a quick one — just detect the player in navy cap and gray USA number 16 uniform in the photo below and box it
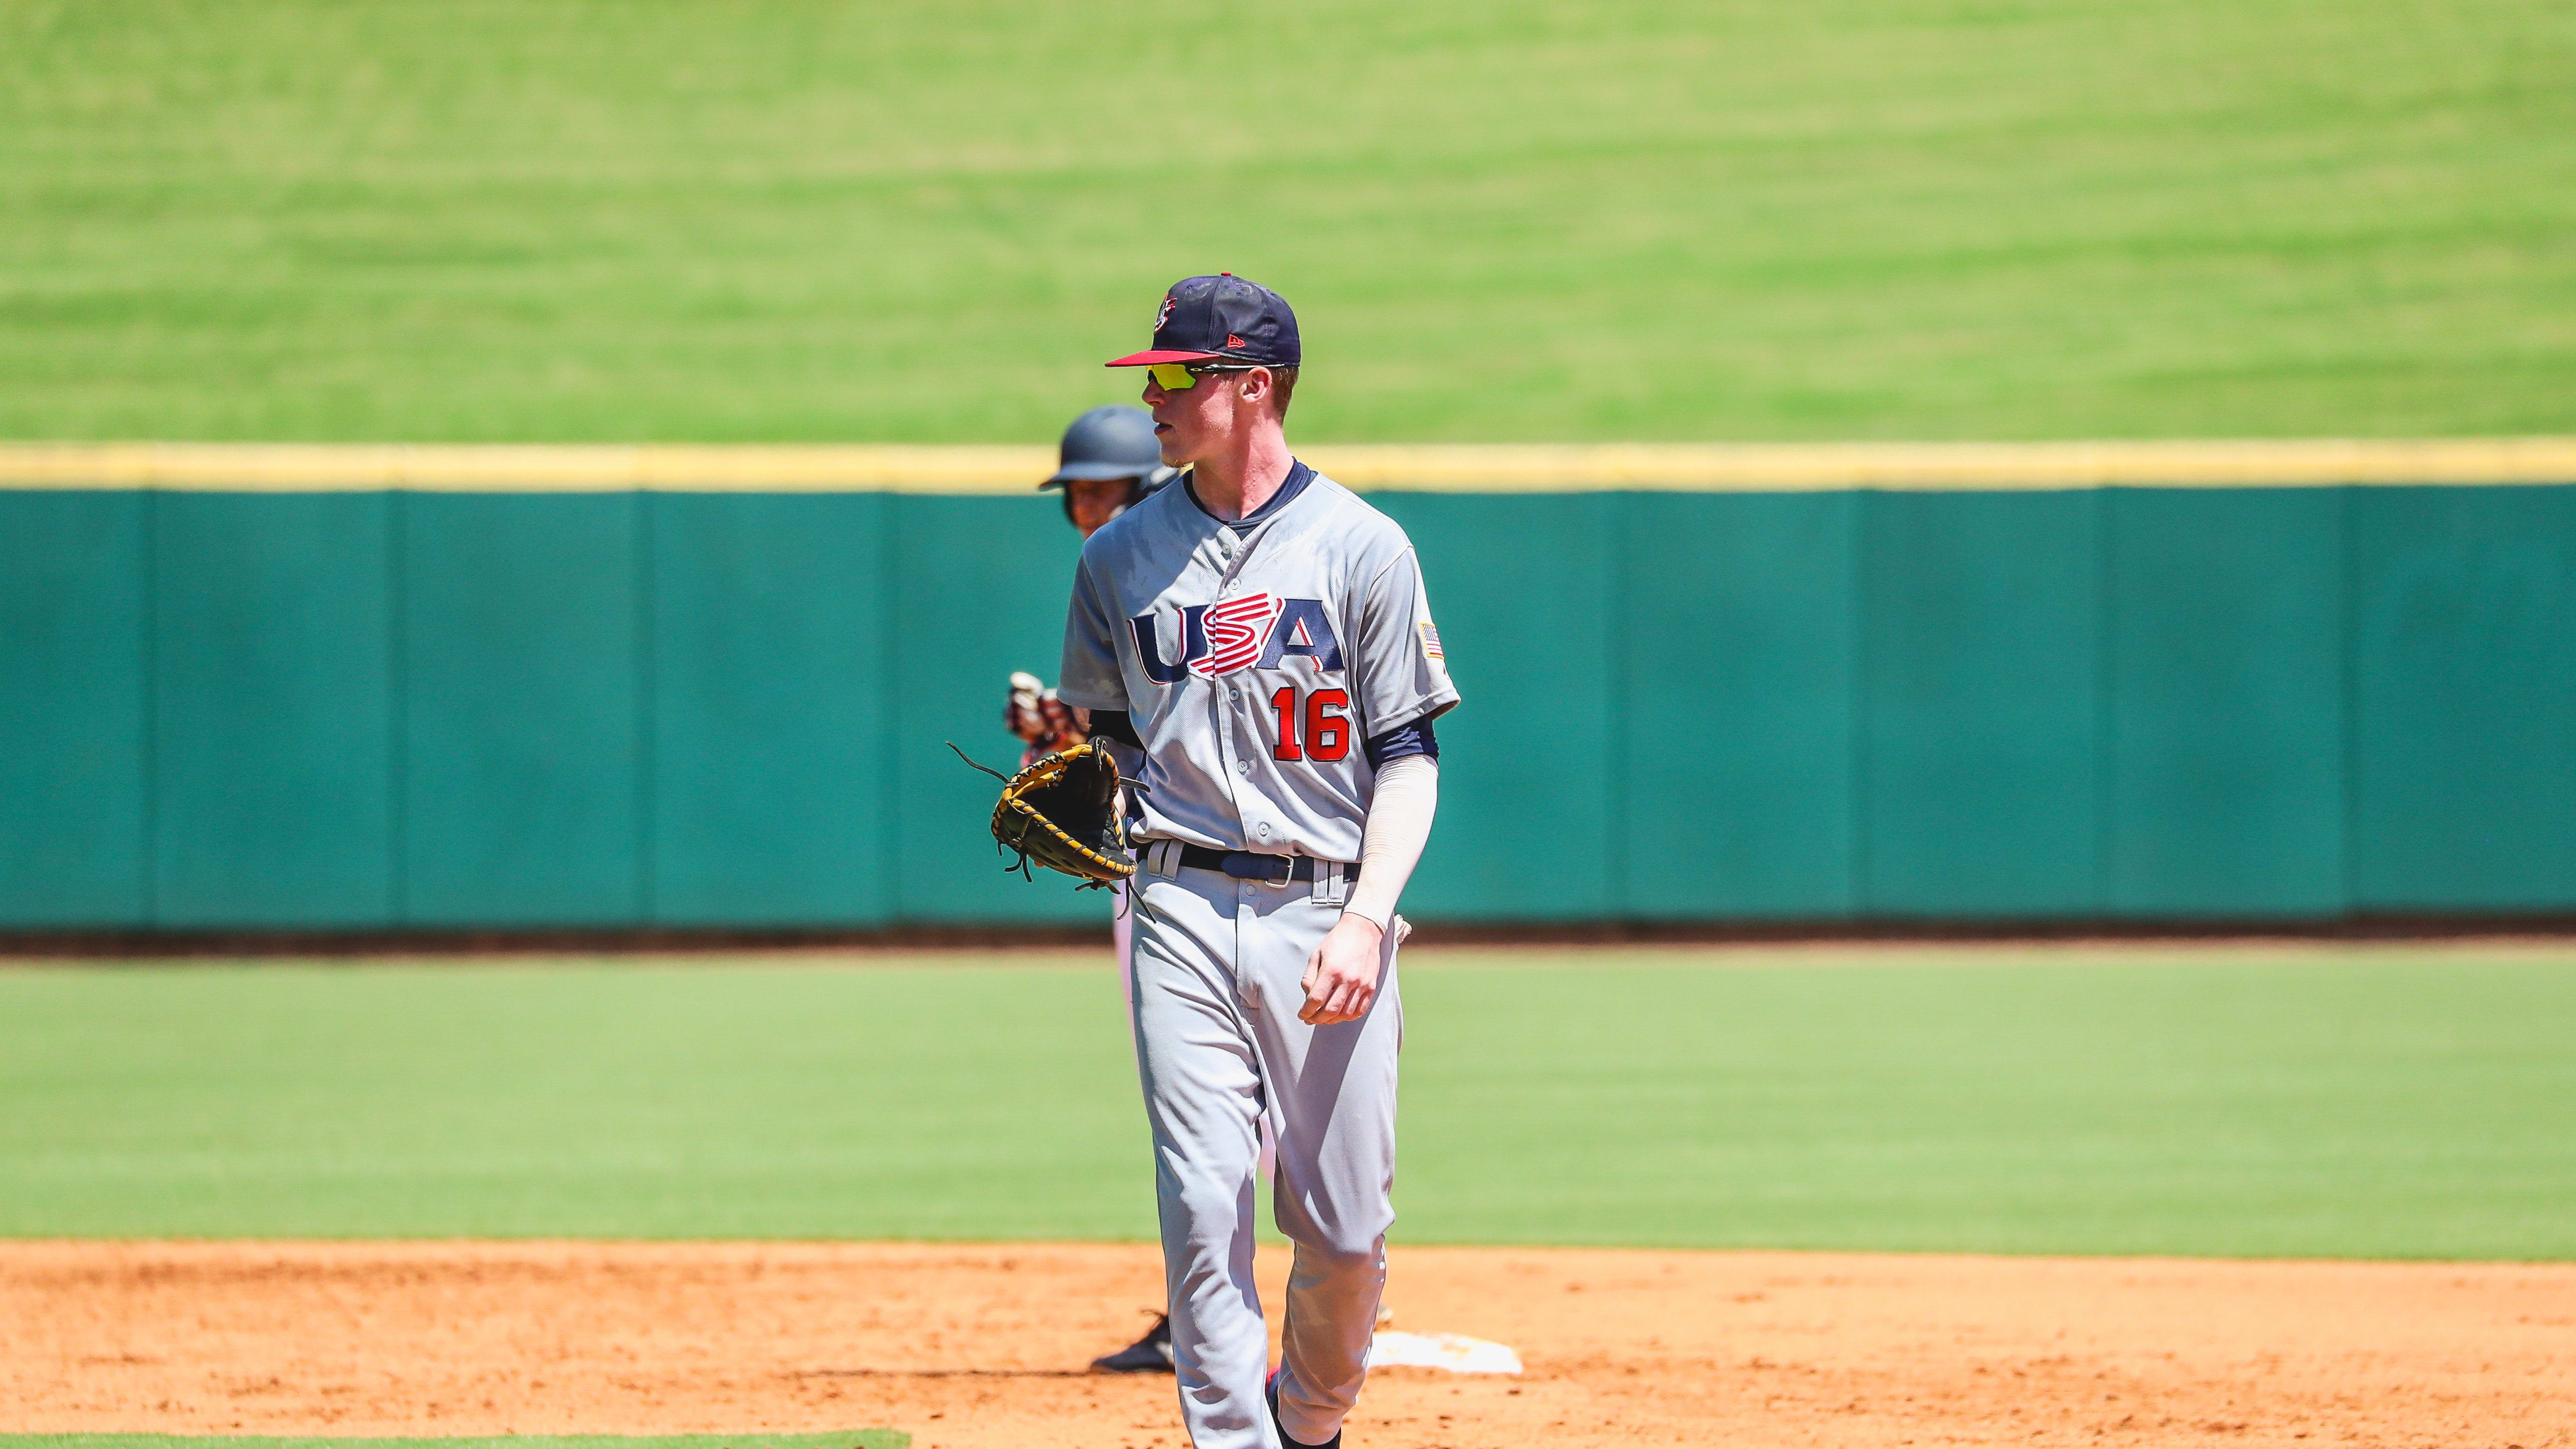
[1061,273,1458,1449]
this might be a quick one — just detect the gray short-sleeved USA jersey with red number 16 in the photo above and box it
[1059,464,1458,861]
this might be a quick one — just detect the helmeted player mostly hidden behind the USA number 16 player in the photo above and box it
[1002,405,1172,1374]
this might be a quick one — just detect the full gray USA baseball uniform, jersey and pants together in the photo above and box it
[1061,464,1458,1449]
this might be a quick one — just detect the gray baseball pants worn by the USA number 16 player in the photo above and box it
[1131,853,1404,1449]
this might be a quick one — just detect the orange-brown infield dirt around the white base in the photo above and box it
[0,1227,2576,1449]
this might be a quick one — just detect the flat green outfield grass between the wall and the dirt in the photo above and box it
[0,949,2576,1258]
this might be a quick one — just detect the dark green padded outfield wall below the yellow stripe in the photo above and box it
[0,443,2576,931]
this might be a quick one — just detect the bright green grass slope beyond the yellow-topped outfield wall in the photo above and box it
[0,0,2576,441]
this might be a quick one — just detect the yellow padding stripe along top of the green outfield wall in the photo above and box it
[0,438,2576,495]
